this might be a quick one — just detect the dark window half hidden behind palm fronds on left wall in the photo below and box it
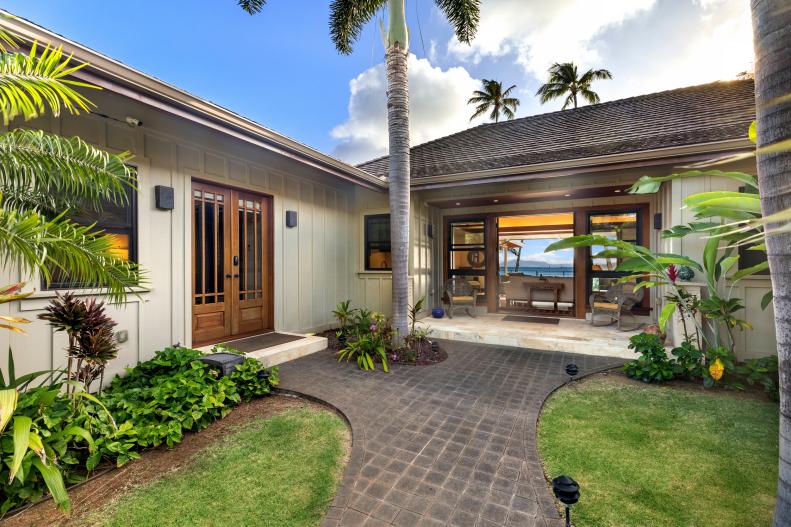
[45,180,137,289]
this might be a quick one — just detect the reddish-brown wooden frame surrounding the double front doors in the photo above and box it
[189,177,275,346]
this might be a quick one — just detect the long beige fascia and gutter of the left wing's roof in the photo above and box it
[0,10,387,190]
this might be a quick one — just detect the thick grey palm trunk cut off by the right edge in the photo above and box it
[751,0,791,527]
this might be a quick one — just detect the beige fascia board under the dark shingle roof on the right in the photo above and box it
[412,138,755,190]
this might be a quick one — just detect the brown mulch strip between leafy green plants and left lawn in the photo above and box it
[0,395,351,527]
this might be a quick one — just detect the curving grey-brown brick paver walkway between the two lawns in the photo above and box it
[281,341,623,527]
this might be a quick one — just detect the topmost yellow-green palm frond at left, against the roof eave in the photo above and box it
[0,42,99,125]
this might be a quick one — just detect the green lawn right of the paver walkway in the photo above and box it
[538,375,778,527]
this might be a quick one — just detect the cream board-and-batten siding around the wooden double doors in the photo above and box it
[0,88,357,379]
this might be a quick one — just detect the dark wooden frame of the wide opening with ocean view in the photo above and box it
[442,201,651,319]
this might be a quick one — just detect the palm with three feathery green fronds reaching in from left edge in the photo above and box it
[0,29,141,301]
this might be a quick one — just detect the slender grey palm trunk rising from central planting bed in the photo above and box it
[386,38,410,343]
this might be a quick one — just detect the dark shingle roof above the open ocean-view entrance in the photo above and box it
[358,80,755,179]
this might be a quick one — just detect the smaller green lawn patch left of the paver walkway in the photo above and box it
[88,409,346,527]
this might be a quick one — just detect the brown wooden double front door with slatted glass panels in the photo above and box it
[192,181,273,344]
